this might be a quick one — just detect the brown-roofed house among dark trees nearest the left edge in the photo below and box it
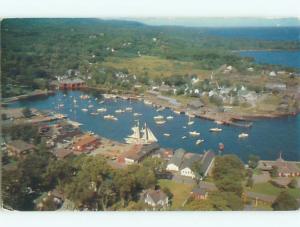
[7,140,36,157]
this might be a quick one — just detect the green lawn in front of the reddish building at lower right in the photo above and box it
[250,182,300,198]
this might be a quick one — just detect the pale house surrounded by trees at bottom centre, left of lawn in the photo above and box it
[141,189,169,208]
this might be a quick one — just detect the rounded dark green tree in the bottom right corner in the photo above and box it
[272,191,299,210]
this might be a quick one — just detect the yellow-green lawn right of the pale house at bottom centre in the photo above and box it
[158,180,194,209]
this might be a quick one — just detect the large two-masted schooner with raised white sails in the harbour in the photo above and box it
[125,121,157,144]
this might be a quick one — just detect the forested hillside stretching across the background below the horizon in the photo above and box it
[1,19,300,96]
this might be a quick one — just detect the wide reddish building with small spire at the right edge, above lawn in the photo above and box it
[258,154,300,177]
